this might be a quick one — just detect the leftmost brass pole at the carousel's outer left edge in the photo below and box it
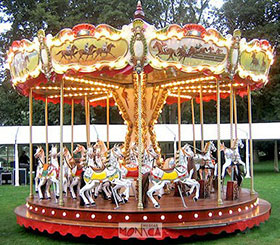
[29,88,34,199]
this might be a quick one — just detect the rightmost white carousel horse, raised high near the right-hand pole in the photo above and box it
[221,139,246,178]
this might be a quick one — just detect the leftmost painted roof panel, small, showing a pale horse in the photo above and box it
[11,51,39,78]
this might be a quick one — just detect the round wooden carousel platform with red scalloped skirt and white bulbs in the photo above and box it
[15,189,271,240]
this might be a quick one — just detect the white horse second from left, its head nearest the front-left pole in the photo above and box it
[38,145,59,199]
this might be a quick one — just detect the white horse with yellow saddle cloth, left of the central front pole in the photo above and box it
[80,145,131,205]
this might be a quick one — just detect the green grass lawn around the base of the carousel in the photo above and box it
[0,162,280,245]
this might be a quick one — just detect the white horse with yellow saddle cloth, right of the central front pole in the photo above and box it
[143,144,200,208]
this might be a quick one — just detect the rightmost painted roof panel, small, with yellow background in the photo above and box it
[240,51,270,75]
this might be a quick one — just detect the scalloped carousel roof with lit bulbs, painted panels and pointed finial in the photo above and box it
[7,1,273,105]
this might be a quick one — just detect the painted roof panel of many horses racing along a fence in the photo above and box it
[150,38,228,66]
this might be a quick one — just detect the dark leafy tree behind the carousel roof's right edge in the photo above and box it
[214,0,280,122]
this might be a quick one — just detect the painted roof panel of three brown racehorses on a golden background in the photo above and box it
[51,37,128,66]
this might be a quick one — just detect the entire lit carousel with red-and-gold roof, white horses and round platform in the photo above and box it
[7,2,273,239]
